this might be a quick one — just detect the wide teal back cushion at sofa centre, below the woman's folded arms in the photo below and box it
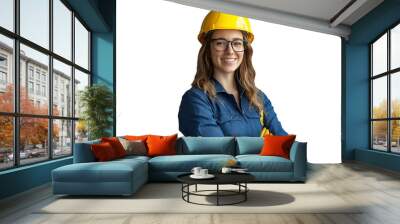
[177,137,235,155]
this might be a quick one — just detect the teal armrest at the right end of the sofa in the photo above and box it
[290,141,307,181]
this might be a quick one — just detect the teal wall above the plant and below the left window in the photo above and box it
[0,0,116,199]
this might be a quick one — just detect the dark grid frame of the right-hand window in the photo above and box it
[368,21,400,155]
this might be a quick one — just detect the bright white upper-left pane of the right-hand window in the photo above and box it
[372,34,387,75]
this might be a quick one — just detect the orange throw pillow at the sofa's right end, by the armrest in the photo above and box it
[260,135,296,159]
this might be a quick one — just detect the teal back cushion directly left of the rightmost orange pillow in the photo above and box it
[236,137,264,155]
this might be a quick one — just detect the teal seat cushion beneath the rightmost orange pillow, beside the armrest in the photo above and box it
[236,155,293,172]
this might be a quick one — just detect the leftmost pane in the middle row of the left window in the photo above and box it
[0,35,14,112]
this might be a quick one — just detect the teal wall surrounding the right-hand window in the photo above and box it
[342,0,400,170]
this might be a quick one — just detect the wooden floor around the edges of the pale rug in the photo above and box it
[0,163,400,224]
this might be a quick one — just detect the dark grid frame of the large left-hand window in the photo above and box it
[0,0,93,172]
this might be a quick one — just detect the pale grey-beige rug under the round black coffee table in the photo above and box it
[36,183,360,214]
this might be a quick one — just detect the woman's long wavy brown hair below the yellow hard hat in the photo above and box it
[192,30,263,111]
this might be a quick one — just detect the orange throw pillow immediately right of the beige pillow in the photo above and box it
[146,134,178,156]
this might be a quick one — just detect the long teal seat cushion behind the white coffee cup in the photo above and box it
[149,154,235,172]
